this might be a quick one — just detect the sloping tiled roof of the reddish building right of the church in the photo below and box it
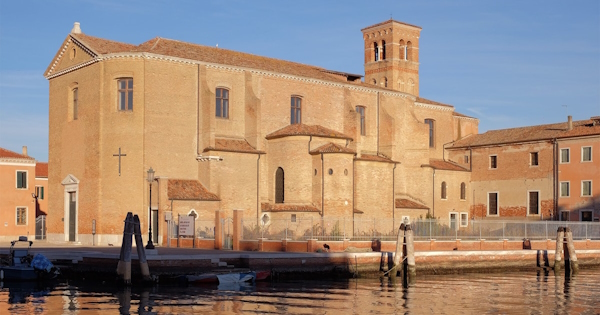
[450,120,600,148]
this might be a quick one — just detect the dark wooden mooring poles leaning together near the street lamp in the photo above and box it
[117,212,152,286]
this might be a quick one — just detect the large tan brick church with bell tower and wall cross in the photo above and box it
[45,20,478,244]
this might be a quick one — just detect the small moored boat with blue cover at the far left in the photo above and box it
[0,236,59,281]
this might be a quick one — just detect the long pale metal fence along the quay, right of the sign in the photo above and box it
[242,218,600,241]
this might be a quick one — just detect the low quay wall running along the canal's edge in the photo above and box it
[0,241,600,281]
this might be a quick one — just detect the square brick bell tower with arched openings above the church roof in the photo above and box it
[361,19,421,96]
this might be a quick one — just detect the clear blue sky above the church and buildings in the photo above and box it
[0,0,600,161]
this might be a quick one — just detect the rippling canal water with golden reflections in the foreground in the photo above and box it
[0,268,600,314]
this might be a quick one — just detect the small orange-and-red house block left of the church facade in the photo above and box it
[0,146,48,241]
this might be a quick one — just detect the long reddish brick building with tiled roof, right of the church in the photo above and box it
[448,116,600,221]
